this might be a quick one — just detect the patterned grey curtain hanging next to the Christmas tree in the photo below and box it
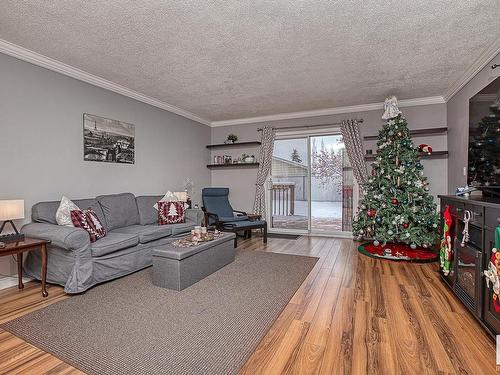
[340,120,368,194]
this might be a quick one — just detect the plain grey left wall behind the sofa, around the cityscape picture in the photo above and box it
[0,54,210,274]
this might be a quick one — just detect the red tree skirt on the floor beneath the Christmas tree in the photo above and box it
[358,242,438,263]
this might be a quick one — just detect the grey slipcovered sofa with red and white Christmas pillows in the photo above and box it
[21,193,203,293]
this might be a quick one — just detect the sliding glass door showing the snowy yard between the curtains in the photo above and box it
[269,132,353,234]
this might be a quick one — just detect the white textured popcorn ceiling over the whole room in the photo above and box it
[0,0,500,121]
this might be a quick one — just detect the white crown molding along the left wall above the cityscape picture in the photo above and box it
[0,39,210,125]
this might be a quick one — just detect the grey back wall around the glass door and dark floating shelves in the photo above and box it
[212,104,447,211]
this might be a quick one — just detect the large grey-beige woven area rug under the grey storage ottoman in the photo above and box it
[0,251,317,375]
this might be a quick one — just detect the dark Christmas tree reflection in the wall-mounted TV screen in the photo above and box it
[467,94,500,186]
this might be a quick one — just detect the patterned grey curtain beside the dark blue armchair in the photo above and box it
[253,126,276,217]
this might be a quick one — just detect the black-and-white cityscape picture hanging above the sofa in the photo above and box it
[83,113,135,164]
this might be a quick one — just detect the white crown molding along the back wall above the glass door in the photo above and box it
[210,96,445,127]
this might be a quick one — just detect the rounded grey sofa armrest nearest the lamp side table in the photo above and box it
[21,223,90,251]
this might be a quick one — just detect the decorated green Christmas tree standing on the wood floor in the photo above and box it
[353,98,439,249]
